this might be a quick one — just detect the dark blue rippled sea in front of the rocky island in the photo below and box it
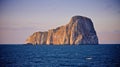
[0,44,120,67]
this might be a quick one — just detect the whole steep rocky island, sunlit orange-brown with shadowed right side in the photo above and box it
[26,16,98,45]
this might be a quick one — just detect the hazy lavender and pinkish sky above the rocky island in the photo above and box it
[0,0,120,44]
